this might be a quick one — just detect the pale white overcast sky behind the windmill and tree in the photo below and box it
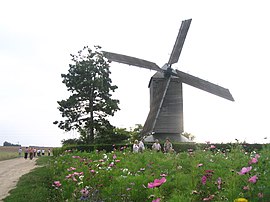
[0,0,270,146]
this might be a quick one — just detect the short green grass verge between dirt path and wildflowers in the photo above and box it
[4,156,53,202]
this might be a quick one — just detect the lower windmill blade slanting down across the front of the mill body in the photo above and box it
[142,77,171,135]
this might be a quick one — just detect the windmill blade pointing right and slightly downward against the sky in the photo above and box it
[175,70,234,101]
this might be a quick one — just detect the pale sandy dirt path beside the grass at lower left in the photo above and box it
[0,158,36,201]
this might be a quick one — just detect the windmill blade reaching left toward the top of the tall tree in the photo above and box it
[102,51,163,72]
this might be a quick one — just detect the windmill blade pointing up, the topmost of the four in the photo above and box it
[168,19,192,65]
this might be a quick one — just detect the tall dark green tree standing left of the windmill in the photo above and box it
[54,46,119,143]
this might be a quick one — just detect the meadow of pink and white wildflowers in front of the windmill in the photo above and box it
[47,144,270,202]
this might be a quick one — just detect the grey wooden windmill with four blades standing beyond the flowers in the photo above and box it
[103,19,234,141]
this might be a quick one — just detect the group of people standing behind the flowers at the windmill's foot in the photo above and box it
[133,138,173,153]
